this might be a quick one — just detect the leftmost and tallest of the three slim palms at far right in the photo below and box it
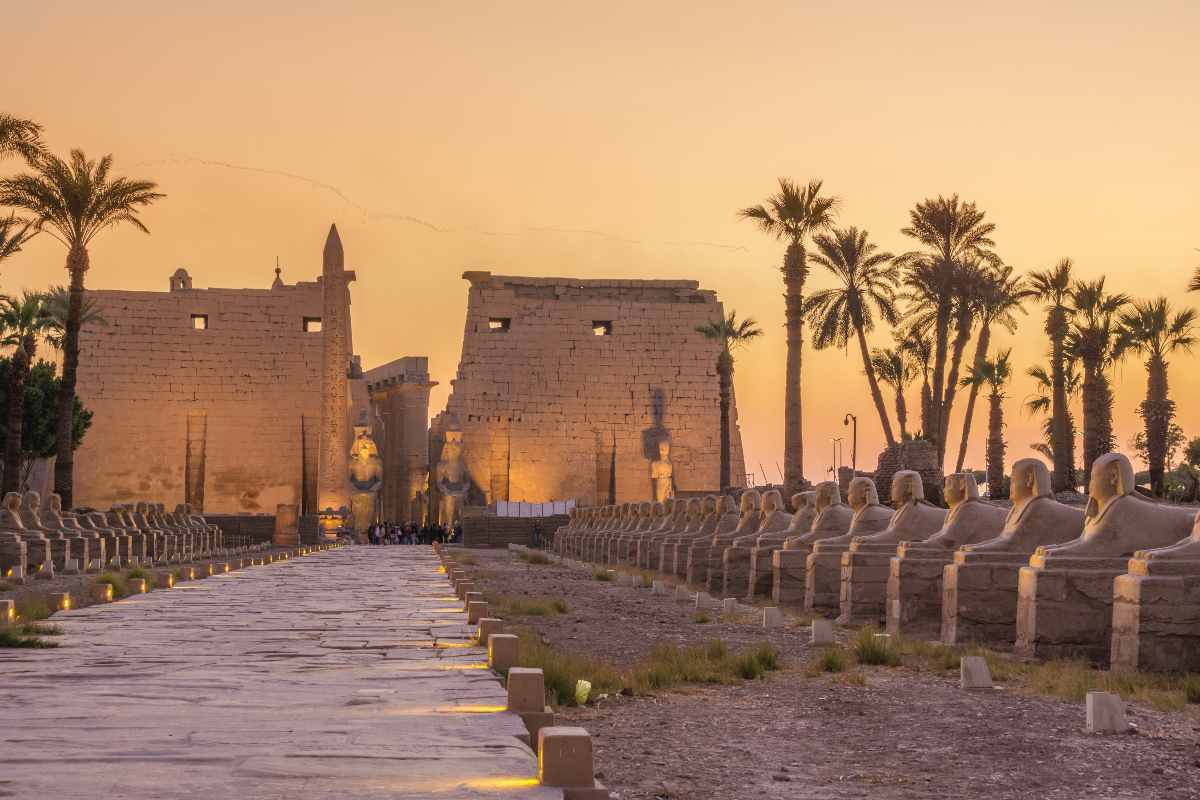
[1030,258,1075,492]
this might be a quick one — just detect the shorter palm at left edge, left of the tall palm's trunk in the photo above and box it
[0,291,50,494]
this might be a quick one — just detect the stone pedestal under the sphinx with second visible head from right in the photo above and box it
[942,553,1030,648]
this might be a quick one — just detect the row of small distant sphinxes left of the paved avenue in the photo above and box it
[0,492,247,579]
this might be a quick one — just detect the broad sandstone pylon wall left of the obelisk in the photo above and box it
[74,262,365,513]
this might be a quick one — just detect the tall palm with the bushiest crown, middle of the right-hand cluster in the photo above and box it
[896,194,1000,470]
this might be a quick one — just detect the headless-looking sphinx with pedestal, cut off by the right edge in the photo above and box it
[1111,515,1200,673]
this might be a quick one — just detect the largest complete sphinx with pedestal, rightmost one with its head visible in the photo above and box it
[1015,453,1195,663]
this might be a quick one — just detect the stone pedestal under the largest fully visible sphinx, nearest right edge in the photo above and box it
[1014,559,1128,666]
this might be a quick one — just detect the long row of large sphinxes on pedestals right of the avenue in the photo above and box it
[553,453,1200,672]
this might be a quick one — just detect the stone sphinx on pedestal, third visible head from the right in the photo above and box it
[884,473,1008,639]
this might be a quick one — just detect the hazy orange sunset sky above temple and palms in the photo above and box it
[0,0,1200,480]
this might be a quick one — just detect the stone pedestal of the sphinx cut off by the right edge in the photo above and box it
[1111,564,1200,672]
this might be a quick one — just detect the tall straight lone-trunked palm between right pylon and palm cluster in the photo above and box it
[739,178,839,497]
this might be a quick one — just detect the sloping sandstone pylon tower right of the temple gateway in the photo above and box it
[430,272,745,505]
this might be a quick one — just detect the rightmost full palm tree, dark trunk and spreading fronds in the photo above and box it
[1118,297,1196,498]
